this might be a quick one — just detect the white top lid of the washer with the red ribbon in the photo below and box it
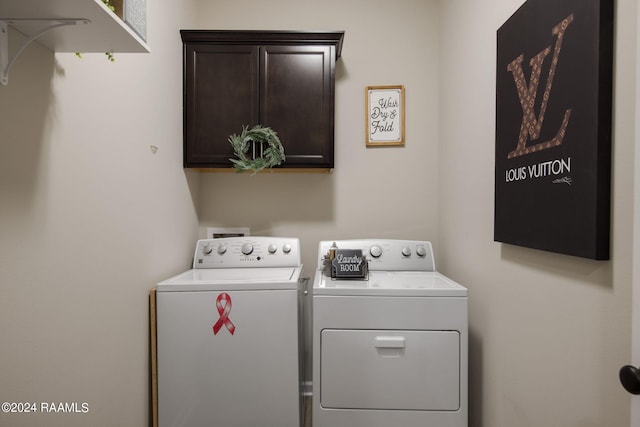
[157,267,301,292]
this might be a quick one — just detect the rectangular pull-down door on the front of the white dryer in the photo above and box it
[320,329,460,411]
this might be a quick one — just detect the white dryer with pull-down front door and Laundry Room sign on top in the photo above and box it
[313,239,468,427]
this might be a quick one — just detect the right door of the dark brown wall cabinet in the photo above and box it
[260,45,335,168]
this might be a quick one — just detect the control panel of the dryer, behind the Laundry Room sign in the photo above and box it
[318,239,435,271]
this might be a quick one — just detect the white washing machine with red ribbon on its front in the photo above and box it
[156,236,302,427]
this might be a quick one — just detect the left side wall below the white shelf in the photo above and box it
[0,0,198,427]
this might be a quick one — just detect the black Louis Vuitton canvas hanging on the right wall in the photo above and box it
[494,0,613,260]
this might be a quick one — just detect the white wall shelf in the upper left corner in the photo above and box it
[0,0,149,53]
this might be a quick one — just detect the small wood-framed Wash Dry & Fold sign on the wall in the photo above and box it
[365,86,404,147]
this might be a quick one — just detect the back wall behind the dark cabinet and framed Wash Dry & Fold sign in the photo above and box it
[197,0,439,274]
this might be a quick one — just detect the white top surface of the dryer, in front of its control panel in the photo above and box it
[313,271,467,297]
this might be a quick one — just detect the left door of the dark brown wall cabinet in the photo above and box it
[184,43,259,167]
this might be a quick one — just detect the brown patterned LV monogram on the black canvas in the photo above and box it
[507,14,573,159]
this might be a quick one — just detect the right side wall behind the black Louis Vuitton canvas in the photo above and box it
[439,0,636,427]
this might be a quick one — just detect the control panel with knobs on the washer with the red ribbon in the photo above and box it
[193,236,301,268]
